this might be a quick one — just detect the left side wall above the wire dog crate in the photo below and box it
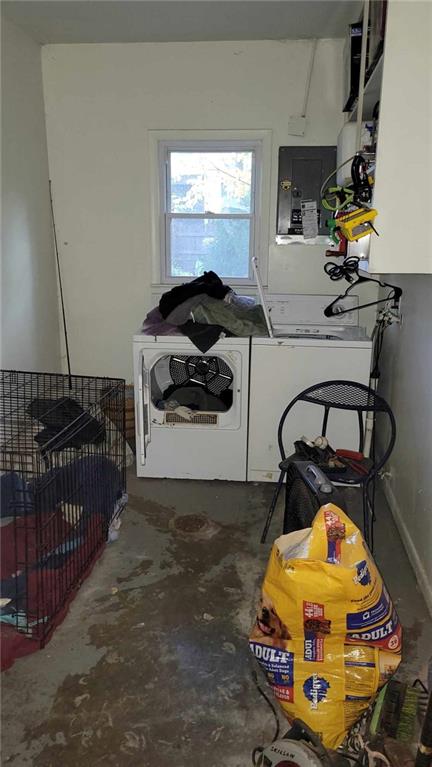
[1,20,61,372]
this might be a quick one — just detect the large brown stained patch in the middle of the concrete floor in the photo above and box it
[15,510,264,767]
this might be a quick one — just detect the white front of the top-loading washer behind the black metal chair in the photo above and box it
[248,338,371,482]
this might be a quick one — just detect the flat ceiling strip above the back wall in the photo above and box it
[1,0,361,43]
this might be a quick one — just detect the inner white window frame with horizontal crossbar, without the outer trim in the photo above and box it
[157,136,264,285]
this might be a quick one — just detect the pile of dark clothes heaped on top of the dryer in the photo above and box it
[142,271,268,354]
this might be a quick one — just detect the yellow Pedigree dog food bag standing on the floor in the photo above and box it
[249,503,402,748]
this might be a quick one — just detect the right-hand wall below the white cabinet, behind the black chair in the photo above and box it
[380,274,432,612]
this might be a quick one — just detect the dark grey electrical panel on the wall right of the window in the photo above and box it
[277,146,336,236]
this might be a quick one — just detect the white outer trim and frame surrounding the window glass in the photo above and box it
[149,130,271,287]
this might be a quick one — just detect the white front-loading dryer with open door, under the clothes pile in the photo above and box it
[133,332,250,481]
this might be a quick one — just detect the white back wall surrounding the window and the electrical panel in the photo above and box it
[43,40,374,378]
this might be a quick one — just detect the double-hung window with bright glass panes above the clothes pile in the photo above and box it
[159,141,261,282]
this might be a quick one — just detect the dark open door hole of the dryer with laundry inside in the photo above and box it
[151,354,234,413]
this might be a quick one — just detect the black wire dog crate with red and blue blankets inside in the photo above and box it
[0,370,127,646]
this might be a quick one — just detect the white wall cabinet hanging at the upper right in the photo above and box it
[369,0,432,274]
